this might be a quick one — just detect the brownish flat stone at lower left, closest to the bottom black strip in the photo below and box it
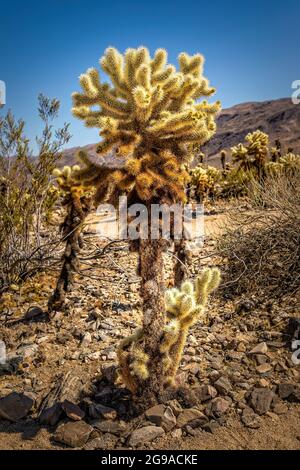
[53,421,93,447]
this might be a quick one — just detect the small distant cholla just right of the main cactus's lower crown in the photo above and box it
[190,165,222,201]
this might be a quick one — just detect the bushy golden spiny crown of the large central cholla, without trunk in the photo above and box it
[73,47,220,201]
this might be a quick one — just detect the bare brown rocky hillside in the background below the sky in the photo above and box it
[63,98,300,165]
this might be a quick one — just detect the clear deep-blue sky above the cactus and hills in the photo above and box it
[0,0,300,146]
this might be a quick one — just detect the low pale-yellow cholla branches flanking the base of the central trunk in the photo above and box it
[118,268,220,393]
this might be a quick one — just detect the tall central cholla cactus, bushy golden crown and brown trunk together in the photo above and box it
[73,47,220,402]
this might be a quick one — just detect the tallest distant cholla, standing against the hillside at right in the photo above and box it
[231,130,269,177]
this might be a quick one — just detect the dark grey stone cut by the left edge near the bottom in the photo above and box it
[0,392,34,421]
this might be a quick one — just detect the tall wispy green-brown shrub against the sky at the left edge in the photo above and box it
[0,94,70,292]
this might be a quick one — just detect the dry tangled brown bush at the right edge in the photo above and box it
[218,171,300,296]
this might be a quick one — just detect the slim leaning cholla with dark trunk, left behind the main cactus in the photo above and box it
[48,165,90,311]
